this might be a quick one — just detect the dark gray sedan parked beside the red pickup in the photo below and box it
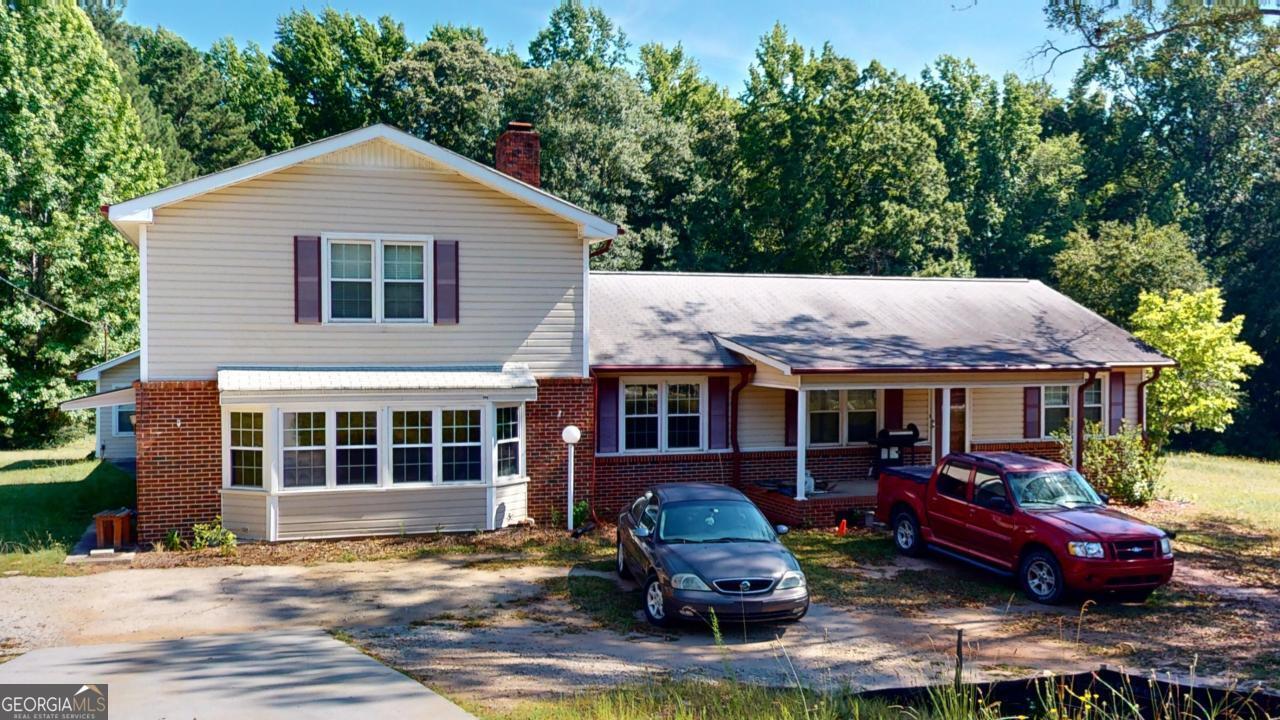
[617,483,809,625]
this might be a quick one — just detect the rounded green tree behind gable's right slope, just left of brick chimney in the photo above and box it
[378,27,520,161]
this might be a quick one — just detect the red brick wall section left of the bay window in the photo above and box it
[134,380,223,542]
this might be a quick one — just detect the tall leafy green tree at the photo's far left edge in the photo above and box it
[0,0,163,447]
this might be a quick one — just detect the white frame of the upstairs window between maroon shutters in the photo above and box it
[320,232,435,325]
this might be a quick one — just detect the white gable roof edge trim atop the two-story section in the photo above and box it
[106,124,618,242]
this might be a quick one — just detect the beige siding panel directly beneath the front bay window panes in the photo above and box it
[278,486,489,539]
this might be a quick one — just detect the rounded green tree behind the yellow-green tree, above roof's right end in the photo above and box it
[1053,219,1208,325]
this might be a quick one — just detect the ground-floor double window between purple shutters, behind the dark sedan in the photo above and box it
[621,379,707,452]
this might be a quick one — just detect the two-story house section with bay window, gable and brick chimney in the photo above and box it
[91,123,617,541]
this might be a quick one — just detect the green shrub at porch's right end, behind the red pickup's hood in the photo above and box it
[1053,423,1165,506]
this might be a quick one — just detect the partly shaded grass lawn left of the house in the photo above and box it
[0,438,134,574]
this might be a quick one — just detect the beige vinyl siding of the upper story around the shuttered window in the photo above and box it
[146,141,584,379]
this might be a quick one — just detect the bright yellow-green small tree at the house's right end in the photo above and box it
[1130,287,1262,445]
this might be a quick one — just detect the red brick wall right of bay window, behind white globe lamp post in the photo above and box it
[525,378,595,524]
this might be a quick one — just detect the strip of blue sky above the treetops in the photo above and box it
[125,0,1079,94]
